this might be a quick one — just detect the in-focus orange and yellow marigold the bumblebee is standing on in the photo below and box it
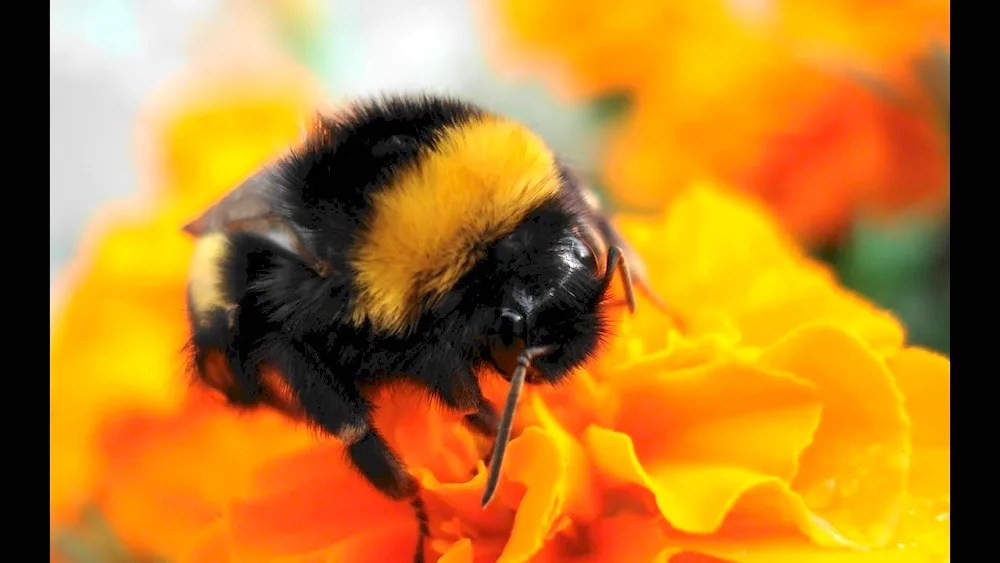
[50,151,950,563]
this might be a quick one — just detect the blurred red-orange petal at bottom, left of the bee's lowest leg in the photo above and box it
[230,442,417,561]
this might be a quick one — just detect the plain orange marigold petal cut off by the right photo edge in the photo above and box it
[886,348,951,498]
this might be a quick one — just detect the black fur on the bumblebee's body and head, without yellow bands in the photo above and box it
[192,97,620,556]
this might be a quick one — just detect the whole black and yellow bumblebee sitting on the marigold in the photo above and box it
[185,95,664,560]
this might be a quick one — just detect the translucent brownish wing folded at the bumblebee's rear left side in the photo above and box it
[183,167,332,276]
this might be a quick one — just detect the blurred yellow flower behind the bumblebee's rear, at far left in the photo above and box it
[50,47,319,521]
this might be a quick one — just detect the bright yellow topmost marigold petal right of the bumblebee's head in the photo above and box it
[619,182,903,349]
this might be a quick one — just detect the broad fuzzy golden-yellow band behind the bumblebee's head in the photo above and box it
[352,116,560,333]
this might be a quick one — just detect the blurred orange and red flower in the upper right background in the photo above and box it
[496,0,949,242]
